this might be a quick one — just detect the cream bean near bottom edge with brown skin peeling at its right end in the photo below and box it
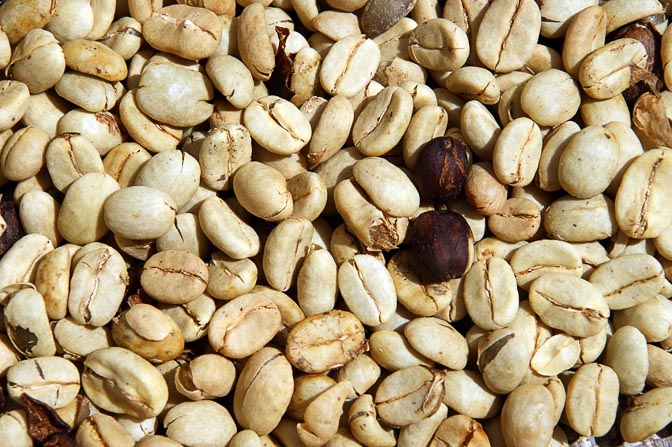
[375,366,445,427]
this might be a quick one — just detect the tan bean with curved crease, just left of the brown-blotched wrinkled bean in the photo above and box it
[208,292,282,358]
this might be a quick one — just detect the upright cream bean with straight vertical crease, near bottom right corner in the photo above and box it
[565,363,618,436]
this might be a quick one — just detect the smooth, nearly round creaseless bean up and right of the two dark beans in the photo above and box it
[520,69,581,126]
